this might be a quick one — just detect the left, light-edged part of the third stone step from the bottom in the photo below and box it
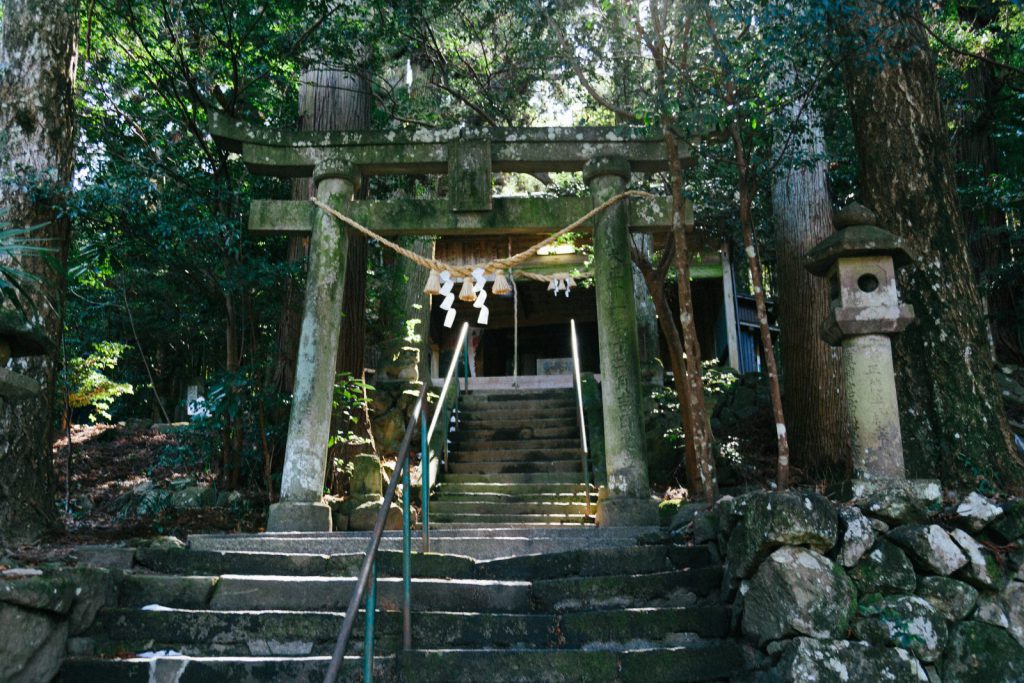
[119,574,530,611]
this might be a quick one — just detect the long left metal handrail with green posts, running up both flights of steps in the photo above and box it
[324,323,471,683]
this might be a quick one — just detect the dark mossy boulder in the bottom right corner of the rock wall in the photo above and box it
[939,622,1024,683]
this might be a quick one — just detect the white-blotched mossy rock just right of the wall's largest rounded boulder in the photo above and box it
[854,595,949,661]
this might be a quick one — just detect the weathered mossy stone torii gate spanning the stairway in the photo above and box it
[210,113,692,531]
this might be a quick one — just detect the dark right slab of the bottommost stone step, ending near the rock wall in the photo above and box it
[397,640,753,683]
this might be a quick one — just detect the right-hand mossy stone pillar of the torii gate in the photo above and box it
[583,158,657,526]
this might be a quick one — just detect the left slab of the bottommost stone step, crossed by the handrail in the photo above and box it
[59,654,397,683]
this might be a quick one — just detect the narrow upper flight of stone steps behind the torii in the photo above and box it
[430,389,597,528]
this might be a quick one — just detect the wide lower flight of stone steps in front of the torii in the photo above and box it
[58,526,758,683]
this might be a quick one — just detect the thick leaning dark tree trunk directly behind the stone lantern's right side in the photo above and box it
[834,0,1024,490]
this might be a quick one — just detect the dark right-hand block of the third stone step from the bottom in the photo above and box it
[532,566,722,611]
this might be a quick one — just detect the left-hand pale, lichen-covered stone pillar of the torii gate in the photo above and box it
[266,161,360,531]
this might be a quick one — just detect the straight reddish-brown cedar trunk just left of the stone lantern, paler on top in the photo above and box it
[772,79,850,481]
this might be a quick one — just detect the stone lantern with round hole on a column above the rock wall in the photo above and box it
[805,203,913,481]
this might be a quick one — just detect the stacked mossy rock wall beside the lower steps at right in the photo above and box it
[677,492,1024,683]
